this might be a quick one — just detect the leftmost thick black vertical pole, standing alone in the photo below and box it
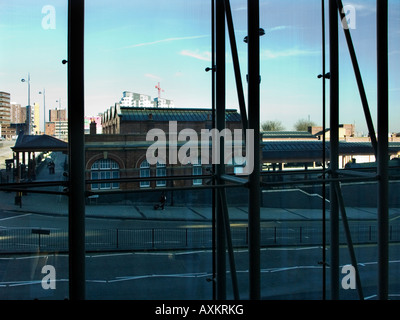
[68,0,85,300]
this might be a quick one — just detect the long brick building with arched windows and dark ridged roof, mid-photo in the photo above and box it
[85,104,242,191]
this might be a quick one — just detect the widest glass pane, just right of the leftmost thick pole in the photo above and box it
[85,0,213,299]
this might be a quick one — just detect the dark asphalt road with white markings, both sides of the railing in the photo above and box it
[0,211,400,300]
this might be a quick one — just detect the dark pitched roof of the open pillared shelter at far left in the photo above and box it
[11,132,68,151]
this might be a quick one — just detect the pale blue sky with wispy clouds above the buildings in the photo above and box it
[0,0,400,133]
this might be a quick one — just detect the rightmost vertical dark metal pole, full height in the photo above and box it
[376,0,389,300]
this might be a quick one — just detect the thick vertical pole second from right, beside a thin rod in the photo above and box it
[329,0,339,300]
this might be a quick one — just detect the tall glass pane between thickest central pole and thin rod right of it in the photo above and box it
[258,1,323,300]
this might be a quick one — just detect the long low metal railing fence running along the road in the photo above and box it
[0,224,400,253]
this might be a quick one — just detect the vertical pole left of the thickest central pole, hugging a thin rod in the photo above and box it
[214,0,226,300]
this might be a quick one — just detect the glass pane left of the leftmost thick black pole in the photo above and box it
[0,0,69,300]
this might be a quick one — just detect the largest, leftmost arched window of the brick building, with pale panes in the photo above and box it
[90,159,119,190]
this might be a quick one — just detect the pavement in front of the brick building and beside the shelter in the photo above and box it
[0,153,400,221]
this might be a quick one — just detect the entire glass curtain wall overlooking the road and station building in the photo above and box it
[0,0,400,300]
